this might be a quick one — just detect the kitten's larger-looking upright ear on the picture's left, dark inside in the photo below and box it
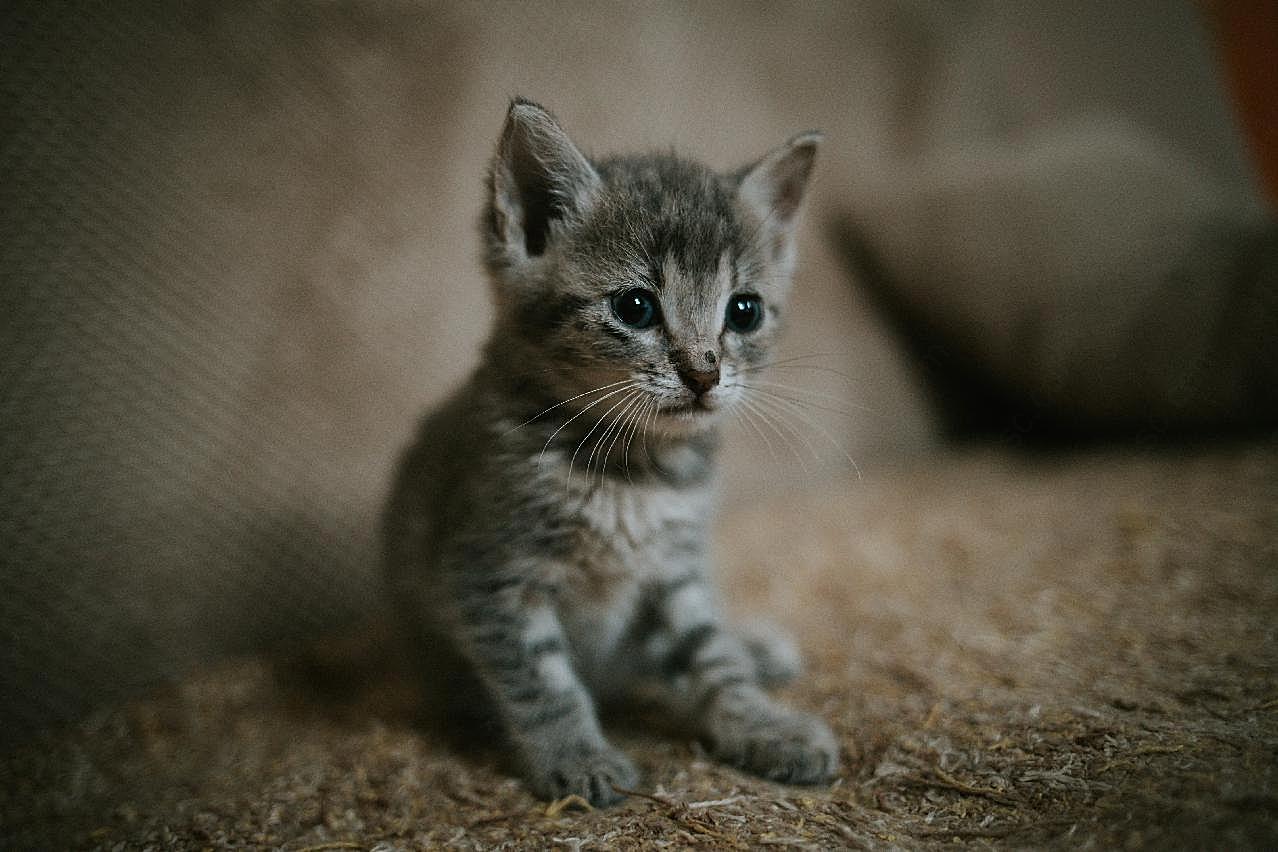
[486,98,599,266]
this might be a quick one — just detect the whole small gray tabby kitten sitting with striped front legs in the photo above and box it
[385,100,838,805]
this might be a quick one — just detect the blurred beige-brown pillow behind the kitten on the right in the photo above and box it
[835,120,1278,441]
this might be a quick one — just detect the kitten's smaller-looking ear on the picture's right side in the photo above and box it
[736,130,824,259]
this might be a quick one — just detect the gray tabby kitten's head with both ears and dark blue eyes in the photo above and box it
[483,100,820,433]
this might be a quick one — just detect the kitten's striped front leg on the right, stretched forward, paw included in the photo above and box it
[643,572,838,784]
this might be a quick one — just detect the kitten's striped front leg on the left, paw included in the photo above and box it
[460,595,638,805]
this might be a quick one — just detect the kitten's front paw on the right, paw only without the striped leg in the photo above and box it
[707,706,838,784]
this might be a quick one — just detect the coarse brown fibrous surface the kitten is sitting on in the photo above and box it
[0,443,1278,849]
